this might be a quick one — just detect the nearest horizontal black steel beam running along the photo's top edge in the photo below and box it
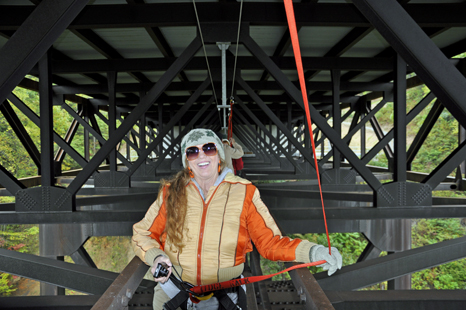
[0,1,466,30]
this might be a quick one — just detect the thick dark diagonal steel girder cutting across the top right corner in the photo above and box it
[353,0,466,127]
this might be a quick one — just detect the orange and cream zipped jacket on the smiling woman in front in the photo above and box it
[132,173,315,285]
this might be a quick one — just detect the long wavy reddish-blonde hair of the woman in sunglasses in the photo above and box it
[159,159,226,253]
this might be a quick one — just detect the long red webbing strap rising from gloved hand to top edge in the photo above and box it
[283,0,335,254]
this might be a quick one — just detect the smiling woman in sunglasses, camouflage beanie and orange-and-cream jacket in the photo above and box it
[132,129,342,309]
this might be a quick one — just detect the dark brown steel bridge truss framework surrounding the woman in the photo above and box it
[0,0,466,310]
